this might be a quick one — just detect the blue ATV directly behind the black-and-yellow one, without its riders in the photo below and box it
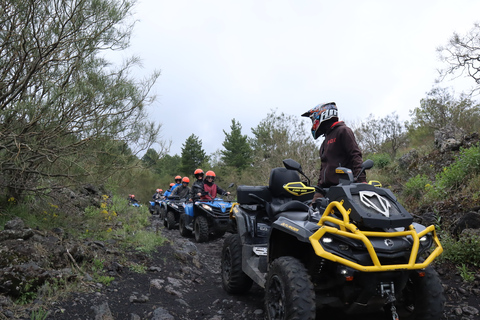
[178,198,232,242]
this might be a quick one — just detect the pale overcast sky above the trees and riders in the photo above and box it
[123,0,480,155]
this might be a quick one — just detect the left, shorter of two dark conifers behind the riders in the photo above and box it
[179,133,209,175]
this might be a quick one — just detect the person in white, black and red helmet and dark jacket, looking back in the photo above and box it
[302,102,366,201]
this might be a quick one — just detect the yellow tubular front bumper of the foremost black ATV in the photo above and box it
[309,201,443,272]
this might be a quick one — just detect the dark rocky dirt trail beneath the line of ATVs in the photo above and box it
[0,216,480,320]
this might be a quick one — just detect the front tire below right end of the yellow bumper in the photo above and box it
[397,266,445,320]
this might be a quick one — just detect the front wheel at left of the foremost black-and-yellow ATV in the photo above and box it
[265,257,316,320]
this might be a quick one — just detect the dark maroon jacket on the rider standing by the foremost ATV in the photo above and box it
[318,121,366,188]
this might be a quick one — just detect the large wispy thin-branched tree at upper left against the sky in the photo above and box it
[0,0,160,199]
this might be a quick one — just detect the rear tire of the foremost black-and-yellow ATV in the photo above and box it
[221,234,253,293]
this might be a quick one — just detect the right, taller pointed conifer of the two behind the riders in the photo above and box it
[221,119,253,172]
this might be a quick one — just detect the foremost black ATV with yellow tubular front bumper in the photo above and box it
[221,159,445,320]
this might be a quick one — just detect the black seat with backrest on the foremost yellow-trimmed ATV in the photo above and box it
[266,168,309,221]
